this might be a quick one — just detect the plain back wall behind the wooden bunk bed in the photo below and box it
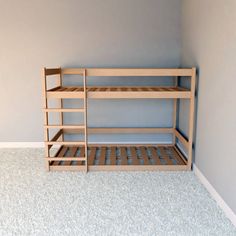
[0,0,181,142]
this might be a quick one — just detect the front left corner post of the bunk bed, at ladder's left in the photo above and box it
[42,68,49,171]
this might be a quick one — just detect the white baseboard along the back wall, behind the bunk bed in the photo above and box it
[0,142,171,148]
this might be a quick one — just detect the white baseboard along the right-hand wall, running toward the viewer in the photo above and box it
[193,165,236,227]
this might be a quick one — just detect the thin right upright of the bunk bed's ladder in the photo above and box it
[83,70,88,172]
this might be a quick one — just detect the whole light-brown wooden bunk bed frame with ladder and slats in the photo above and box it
[42,68,196,172]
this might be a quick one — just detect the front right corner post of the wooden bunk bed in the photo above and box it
[188,68,196,170]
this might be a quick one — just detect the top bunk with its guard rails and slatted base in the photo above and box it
[43,68,196,99]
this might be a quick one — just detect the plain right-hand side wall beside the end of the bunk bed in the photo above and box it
[182,0,236,212]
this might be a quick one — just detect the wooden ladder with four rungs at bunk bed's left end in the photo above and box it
[43,68,88,172]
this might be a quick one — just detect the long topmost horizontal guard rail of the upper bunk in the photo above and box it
[62,68,192,76]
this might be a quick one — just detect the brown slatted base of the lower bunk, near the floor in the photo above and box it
[48,145,188,171]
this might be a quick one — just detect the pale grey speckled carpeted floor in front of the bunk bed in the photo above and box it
[0,149,236,236]
